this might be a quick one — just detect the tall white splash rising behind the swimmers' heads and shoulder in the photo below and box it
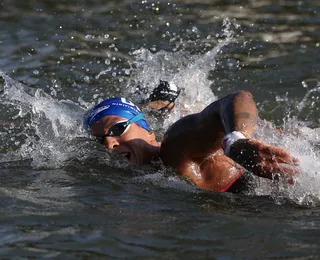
[127,19,238,130]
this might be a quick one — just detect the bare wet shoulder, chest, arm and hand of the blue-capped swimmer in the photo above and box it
[160,91,299,191]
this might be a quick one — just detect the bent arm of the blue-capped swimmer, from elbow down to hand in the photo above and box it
[198,91,299,179]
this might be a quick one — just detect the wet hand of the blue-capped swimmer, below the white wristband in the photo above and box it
[229,139,300,179]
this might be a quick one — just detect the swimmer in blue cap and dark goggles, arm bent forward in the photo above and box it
[86,86,299,192]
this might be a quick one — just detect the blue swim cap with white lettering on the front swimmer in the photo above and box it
[85,98,151,131]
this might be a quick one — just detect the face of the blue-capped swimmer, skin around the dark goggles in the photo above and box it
[91,116,159,165]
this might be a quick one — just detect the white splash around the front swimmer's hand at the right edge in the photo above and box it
[252,111,320,206]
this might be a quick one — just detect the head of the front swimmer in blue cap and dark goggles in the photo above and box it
[85,98,159,165]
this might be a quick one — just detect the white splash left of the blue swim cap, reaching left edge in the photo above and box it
[0,71,84,168]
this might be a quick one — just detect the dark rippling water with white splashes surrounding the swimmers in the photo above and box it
[0,0,320,259]
